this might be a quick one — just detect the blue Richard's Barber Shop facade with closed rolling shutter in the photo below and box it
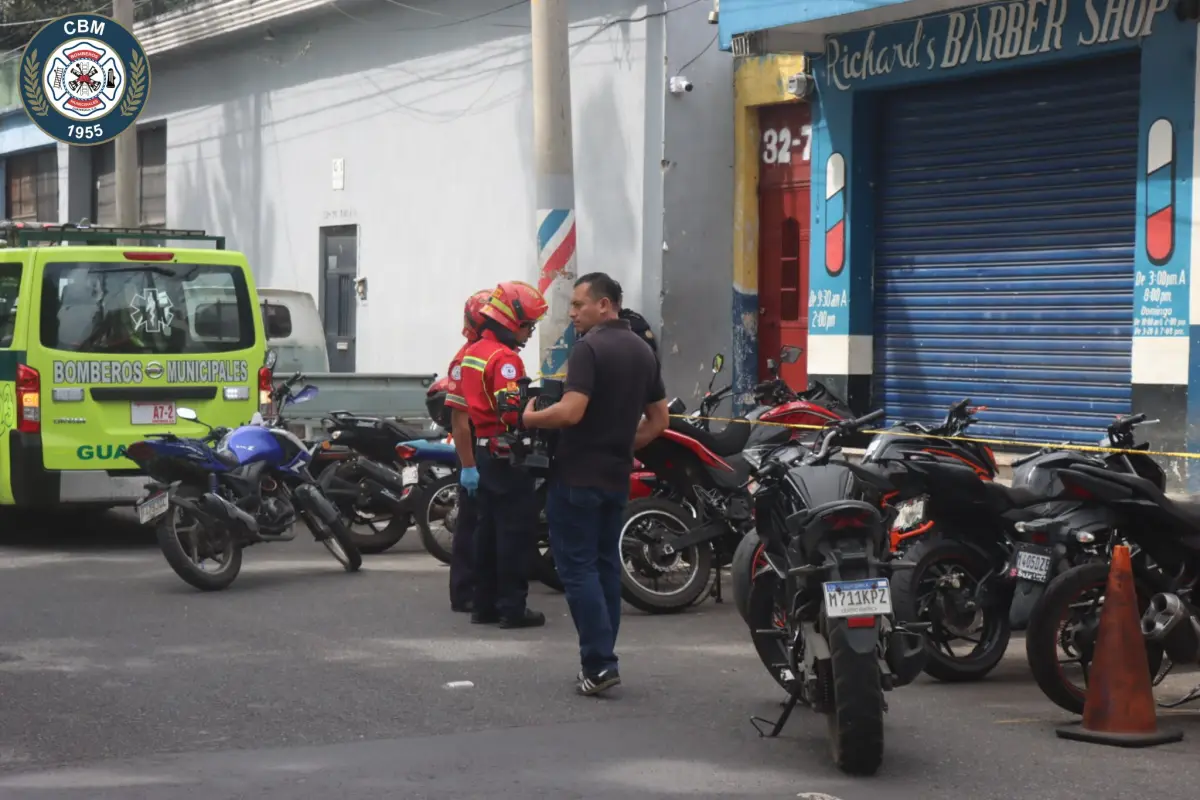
[721,0,1200,486]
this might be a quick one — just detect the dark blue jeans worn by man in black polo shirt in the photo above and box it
[546,481,629,675]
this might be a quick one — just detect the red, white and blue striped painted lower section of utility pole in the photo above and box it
[538,209,575,375]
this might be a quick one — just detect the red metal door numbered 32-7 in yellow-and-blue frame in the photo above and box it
[758,103,812,391]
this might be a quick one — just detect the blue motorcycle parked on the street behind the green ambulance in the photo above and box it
[126,373,362,591]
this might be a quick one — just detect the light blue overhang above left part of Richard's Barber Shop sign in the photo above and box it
[719,0,991,53]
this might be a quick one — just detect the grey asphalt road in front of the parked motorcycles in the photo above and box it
[0,517,1200,800]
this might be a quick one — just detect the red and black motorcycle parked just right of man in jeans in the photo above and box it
[620,348,850,614]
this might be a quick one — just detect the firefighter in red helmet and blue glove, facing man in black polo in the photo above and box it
[448,281,547,627]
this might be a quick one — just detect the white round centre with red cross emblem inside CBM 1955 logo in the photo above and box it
[46,40,125,120]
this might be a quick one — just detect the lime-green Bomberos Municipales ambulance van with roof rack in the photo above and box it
[0,221,271,507]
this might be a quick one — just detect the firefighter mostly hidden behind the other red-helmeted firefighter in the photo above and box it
[445,289,492,613]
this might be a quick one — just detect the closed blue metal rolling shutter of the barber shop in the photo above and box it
[874,53,1140,443]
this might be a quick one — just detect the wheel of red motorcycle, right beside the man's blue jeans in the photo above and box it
[619,498,713,614]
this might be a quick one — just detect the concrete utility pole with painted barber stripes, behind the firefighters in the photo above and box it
[529,0,576,375]
